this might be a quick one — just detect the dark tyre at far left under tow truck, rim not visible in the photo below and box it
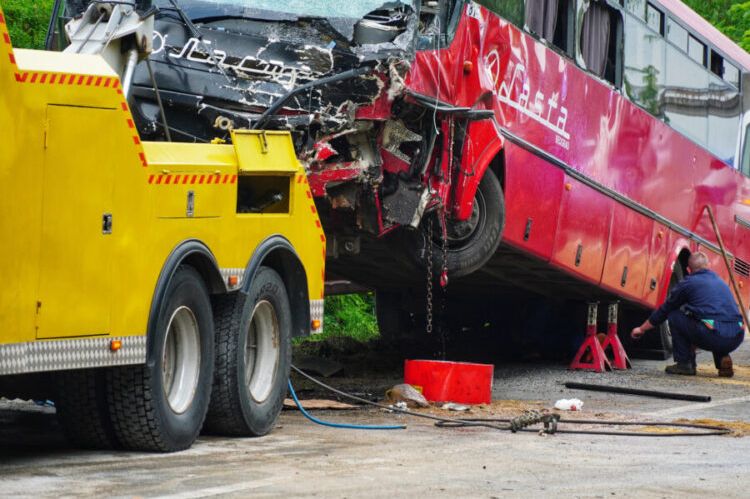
[55,369,119,449]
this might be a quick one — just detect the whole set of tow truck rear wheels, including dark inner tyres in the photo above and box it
[56,266,291,452]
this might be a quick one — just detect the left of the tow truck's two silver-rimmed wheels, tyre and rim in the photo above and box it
[108,266,214,452]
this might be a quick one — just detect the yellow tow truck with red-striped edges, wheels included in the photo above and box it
[0,2,325,451]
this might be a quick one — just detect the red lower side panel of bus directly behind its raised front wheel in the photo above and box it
[503,142,564,260]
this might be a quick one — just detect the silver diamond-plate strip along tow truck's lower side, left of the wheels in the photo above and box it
[0,336,146,375]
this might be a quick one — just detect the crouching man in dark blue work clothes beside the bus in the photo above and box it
[630,252,744,377]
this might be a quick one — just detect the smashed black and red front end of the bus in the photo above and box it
[53,0,502,287]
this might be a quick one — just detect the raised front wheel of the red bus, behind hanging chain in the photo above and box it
[418,170,505,277]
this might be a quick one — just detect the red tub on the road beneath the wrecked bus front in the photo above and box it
[404,360,495,404]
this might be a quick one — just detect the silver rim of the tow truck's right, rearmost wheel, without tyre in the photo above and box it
[245,300,280,403]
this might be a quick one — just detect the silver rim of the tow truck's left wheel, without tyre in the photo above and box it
[162,306,201,414]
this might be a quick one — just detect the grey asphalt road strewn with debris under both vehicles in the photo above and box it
[0,344,750,498]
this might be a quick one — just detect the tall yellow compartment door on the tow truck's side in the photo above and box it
[37,105,115,338]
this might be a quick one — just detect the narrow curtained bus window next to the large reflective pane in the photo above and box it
[581,1,622,86]
